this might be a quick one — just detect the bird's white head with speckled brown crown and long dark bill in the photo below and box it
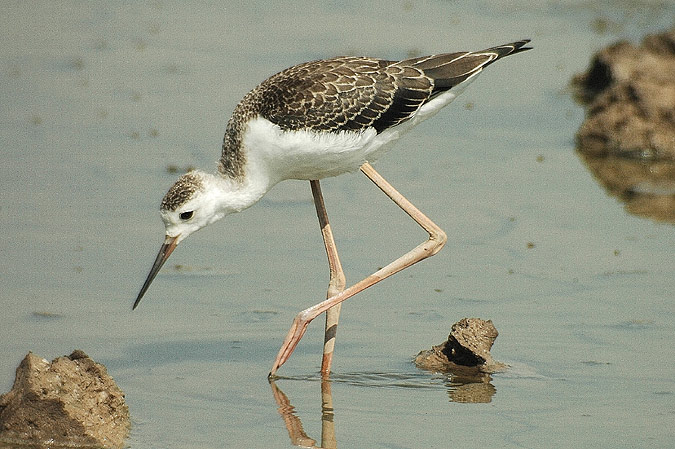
[133,171,230,309]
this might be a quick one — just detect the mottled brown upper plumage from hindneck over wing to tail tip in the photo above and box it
[219,40,529,177]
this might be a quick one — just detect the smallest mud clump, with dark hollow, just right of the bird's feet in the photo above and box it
[415,318,506,373]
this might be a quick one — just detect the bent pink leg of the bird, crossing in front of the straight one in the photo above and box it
[269,162,447,377]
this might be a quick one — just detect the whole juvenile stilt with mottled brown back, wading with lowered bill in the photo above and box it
[133,39,531,376]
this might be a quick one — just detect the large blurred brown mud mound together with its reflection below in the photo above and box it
[572,29,675,222]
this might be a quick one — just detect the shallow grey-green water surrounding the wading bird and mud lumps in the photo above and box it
[0,1,675,448]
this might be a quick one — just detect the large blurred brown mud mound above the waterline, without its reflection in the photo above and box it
[573,29,675,161]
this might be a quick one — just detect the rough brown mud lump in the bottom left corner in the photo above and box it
[0,350,129,448]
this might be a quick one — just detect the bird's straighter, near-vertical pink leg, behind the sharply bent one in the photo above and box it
[310,180,346,376]
